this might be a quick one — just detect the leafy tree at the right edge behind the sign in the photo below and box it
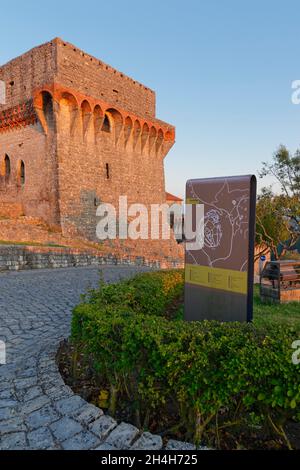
[256,145,300,259]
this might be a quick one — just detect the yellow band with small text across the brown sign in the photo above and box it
[185,264,248,294]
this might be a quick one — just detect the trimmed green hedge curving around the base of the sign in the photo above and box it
[72,271,300,443]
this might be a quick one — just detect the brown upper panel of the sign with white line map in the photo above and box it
[186,178,250,271]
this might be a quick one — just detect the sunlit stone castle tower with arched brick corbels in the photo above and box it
[0,38,175,246]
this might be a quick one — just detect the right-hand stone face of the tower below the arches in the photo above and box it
[57,99,167,240]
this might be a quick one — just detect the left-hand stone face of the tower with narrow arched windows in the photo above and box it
[0,123,60,224]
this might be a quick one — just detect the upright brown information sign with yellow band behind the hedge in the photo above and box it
[185,175,256,321]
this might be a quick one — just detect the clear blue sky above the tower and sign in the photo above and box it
[0,0,300,196]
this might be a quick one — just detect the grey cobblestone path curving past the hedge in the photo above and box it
[0,266,199,450]
